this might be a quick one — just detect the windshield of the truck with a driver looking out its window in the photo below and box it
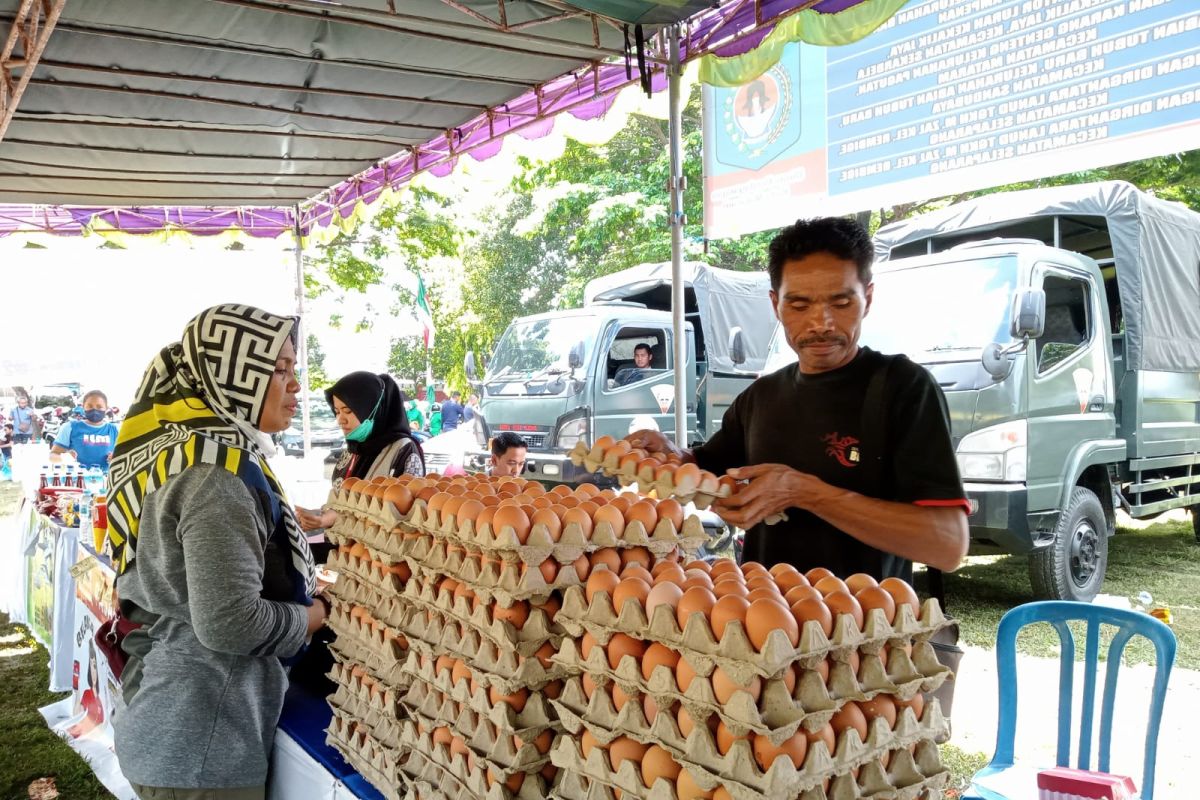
[485,317,595,395]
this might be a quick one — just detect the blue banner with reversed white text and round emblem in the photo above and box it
[704,0,1200,239]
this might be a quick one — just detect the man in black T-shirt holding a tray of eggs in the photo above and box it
[628,217,970,582]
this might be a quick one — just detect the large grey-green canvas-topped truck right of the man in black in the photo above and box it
[766,181,1200,601]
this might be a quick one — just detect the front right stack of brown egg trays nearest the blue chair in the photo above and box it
[552,560,949,800]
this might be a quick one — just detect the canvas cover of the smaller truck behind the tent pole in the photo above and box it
[583,261,775,373]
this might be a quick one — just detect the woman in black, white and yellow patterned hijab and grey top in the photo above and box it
[108,305,328,800]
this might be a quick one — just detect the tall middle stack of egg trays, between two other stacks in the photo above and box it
[335,476,703,800]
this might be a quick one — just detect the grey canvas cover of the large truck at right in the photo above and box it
[875,181,1200,372]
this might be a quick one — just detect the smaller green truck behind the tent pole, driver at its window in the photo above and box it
[466,261,774,485]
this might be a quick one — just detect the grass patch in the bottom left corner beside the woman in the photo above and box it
[0,614,113,800]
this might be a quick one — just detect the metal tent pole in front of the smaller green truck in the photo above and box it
[667,25,688,447]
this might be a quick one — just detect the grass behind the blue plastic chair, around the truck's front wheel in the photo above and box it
[921,522,1200,669]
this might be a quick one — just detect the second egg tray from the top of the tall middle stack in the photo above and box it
[403,535,583,608]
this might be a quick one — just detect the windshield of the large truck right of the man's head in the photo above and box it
[862,257,1016,363]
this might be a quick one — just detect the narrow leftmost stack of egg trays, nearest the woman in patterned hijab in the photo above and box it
[326,479,427,798]
